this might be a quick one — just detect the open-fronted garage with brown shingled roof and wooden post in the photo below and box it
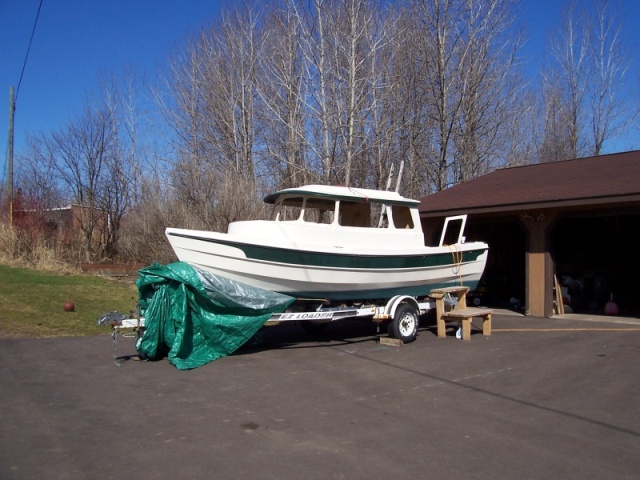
[420,151,640,317]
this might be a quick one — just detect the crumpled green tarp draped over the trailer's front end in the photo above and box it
[136,262,294,370]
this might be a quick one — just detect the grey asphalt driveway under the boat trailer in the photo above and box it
[0,315,640,480]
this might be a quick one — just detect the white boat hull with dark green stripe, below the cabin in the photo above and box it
[166,228,488,300]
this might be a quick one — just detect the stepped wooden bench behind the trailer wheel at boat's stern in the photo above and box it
[429,287,493,340]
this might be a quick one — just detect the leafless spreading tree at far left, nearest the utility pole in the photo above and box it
[15,76,138,262]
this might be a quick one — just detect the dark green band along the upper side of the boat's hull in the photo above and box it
[170,233,486,270]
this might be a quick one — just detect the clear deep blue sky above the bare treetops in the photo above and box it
[0,0,640,186]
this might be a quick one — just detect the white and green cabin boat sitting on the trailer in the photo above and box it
[166,185,488,302]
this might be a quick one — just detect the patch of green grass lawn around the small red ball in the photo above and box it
[0,265,138,337]
